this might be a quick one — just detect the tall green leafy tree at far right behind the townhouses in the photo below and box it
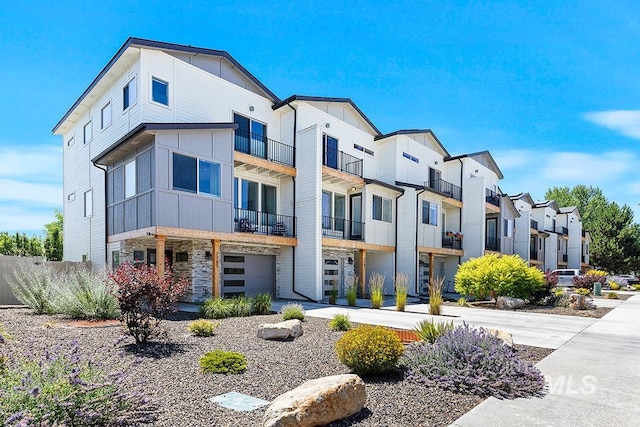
[545,185,640,273]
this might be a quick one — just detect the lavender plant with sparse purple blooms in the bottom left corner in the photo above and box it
[0,342,156,426]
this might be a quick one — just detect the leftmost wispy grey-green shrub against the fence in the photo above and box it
[10,262,57,314]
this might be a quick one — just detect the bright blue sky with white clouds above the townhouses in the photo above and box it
[0,0,640,234]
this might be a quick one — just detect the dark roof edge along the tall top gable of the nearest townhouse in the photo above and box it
[52,37,280,133]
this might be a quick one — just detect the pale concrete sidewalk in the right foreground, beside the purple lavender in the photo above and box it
[452,295,640,427]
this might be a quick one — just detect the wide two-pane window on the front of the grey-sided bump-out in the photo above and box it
[173,153,220,197]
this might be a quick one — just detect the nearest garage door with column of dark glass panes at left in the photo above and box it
[222,254,276,297]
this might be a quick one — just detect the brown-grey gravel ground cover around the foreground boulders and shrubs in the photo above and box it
[0,309,552,427]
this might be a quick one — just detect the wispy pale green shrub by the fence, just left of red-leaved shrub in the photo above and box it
[51,268,120,319]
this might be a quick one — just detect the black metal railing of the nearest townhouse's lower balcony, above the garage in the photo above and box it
[233,208,296,237]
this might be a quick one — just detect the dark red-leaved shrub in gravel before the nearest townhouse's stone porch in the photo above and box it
[109,262,189,344]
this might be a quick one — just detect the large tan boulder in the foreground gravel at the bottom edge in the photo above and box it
[262,374,367,427]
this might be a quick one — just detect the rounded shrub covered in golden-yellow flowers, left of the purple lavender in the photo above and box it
[336,325,404,375]
